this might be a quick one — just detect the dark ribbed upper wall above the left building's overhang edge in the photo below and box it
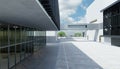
[39,0,60,29]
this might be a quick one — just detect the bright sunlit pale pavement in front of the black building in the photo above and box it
[72,42,120,69]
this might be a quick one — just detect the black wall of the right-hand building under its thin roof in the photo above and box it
[103,1,120,46]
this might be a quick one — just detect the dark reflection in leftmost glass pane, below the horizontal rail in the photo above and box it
[0,48,8,69]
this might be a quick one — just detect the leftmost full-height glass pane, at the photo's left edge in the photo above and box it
[0,23,8,69]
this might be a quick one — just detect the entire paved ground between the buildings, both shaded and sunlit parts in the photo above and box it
[12,41,120,69]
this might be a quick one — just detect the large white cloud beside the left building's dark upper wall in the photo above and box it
[59,0,85,23]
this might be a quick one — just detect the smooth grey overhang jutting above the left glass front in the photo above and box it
[0,0,58,31]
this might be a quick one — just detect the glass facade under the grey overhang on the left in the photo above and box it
[0,23,46,69]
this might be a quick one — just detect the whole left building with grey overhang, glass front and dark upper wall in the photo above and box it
[0,0,60,69]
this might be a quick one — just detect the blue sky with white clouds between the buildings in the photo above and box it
[59,0,94,24]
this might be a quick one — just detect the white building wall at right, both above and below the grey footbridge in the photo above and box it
[85,0,117,41]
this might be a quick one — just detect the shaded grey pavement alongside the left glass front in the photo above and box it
[13,39,103,69]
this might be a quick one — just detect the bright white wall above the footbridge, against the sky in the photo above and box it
[85,0,117,23]
